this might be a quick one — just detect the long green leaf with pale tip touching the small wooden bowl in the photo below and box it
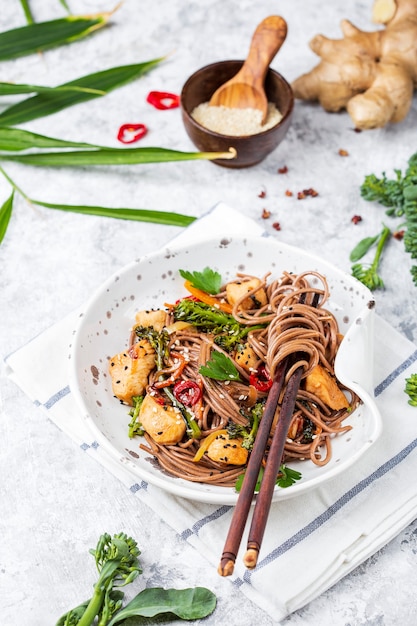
[0,148,236,167]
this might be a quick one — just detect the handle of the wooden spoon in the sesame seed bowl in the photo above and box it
[238,15,287,88]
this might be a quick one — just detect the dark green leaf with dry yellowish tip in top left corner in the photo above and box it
[0,11,114,61]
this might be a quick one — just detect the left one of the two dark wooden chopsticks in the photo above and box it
[217,360,287,576]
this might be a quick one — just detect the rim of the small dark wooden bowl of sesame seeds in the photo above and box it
[180,59,295,141]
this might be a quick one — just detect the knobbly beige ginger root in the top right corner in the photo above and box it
[292,0,417,129]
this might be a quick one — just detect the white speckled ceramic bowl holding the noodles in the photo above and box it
[70,236,381,504]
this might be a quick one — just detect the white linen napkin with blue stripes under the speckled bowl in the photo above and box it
[6,203,417,620]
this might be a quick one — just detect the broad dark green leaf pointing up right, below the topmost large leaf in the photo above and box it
[0,57,163,126]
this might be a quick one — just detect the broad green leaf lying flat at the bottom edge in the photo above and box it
[108,587,216,626]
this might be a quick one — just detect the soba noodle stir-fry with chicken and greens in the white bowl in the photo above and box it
[109,268,359,487]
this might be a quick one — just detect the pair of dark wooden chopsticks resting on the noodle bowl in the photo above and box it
[218,359,303,576]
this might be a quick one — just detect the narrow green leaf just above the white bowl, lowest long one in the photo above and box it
[30,200,196,226]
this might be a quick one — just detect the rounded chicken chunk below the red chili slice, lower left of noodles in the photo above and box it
[138,394,186,446]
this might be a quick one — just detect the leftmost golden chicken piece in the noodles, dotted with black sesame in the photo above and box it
[109,339,155,405]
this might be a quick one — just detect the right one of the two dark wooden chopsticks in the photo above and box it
[243,366,304,569]
